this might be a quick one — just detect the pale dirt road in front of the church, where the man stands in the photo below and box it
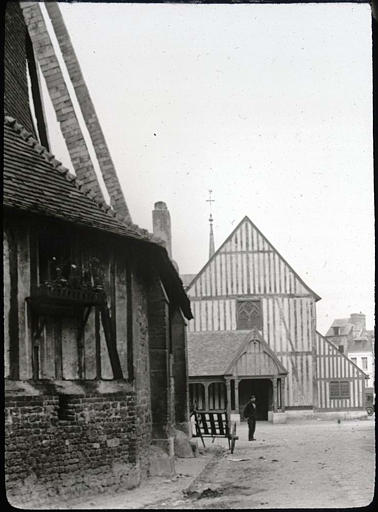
[146,419,375,509]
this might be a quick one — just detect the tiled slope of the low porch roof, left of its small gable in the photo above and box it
[188,331,251,377]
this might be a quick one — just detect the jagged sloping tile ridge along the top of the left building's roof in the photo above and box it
[4,115,164,246]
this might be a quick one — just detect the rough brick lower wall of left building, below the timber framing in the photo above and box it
[5,392,141,506]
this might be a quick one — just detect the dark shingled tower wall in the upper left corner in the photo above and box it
[4,2,35,136]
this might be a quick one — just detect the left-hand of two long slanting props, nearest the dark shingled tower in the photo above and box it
[20,2,105,202]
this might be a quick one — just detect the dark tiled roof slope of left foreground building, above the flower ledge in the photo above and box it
[3,116,161,243]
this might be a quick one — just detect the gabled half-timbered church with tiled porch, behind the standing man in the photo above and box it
[187,217,366,421]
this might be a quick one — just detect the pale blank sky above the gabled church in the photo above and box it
[39,3,374,333]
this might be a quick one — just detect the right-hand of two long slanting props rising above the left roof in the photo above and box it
[45,2,131,222]
